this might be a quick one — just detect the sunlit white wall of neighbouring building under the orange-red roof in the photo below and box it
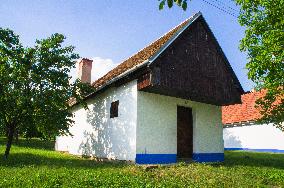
[223,124,284,150]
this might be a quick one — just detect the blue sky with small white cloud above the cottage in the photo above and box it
[0,0,253,90]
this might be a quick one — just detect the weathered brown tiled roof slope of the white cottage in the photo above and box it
[92,13,201,88]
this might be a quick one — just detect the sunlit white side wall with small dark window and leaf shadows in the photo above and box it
[56,80,137,160]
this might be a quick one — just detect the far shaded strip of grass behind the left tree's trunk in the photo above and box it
[0,137,55,150]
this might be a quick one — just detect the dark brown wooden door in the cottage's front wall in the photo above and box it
[177,106,193,158]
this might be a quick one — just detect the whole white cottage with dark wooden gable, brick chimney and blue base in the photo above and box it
[56,13,243,164]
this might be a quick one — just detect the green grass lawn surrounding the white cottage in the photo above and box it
[0,138,284,187]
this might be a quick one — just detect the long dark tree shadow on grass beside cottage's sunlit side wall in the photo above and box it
[0,153,126,169]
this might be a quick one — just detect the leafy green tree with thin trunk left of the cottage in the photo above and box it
[0,28,92,159]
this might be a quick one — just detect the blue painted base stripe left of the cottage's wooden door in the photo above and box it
[135,154,177,164]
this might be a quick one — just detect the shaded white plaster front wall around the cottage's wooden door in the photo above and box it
[136,91,224,154]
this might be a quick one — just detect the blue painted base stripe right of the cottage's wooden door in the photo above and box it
[192,153,224,162]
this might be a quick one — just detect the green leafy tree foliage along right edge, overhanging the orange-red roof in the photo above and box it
[236,0,284,130]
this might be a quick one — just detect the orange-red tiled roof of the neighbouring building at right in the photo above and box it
[222,91,266,124]
